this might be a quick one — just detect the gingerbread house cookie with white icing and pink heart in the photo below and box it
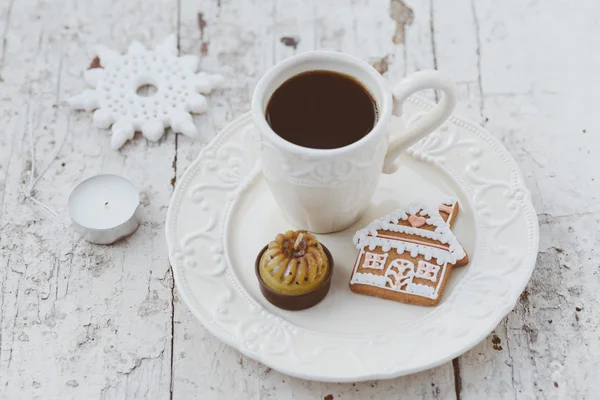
[350,199,469,306]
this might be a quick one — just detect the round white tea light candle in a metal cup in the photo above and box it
[69,175,140,244]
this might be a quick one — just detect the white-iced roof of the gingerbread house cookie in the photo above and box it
[353,199,466,265]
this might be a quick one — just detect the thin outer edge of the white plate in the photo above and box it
[165,97,539,382]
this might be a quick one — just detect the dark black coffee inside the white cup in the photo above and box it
[266,71,377,149]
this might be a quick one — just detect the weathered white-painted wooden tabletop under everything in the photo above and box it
[0,0,600,399]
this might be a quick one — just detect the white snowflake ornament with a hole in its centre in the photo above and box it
[69,35,224,150]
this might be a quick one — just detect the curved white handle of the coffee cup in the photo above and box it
[383,70,457,174]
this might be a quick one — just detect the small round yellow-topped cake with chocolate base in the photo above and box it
[255,231,333,310]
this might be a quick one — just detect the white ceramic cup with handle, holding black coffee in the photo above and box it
[252,51,456,233]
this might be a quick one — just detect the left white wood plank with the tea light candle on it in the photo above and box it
[0,0,176,399]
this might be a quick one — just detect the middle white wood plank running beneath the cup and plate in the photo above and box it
[173,1,455,399]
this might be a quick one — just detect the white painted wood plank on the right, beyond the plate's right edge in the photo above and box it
[435,1,600,399]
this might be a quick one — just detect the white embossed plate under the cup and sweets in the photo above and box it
[166,98,538,382]
